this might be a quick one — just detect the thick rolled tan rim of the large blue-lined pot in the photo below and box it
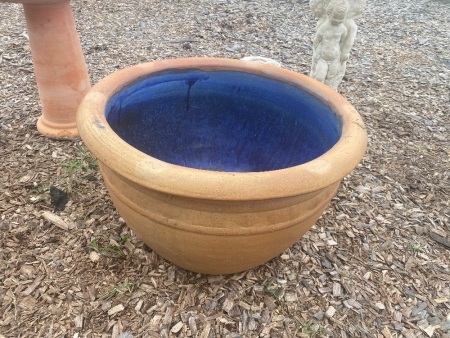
[77,57,367,201]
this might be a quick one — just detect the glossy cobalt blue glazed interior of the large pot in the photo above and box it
[106,69,342,172]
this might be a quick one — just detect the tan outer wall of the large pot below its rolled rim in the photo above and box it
[100,165,339,274]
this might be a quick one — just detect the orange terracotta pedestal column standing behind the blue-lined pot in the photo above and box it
[0,0,91,139]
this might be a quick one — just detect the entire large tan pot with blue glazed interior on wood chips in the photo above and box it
[77,58,367,274]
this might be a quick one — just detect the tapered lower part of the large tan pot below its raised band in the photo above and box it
[108,177,340,275]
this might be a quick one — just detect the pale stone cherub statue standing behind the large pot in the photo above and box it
[309,0,366,90]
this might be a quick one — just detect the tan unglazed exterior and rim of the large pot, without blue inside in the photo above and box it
[77,58,367,274]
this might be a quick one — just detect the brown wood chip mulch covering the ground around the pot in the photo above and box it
[0,0,450,338]
